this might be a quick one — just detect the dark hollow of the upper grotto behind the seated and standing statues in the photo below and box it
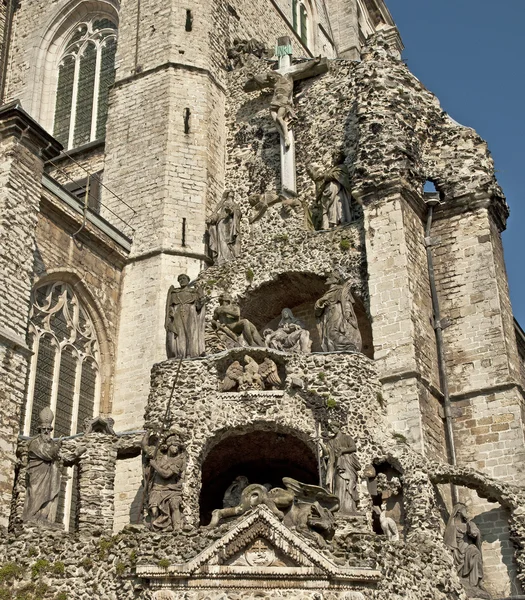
[240,271,374,358]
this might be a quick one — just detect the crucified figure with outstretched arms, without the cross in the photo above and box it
[244,58,321,148]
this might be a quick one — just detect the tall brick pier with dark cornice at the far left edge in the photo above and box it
[0,101,62,526]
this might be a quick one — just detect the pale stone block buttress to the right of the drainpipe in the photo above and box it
[434,208,525,483]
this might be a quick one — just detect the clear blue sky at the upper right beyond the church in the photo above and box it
[386,0,525,328]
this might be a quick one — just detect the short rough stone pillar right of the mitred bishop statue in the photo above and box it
[78,433,117,535]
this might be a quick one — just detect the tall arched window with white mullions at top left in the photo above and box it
[53,17,117,148]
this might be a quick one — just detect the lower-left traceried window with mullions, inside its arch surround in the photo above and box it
[23,282,100,437]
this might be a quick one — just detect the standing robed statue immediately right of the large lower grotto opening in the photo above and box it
[322,431,361,516]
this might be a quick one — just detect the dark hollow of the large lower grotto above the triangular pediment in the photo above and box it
[199,430,319,525]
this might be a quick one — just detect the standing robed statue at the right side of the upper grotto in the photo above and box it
[315,273,362,352]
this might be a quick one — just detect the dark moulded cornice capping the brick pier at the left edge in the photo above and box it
[0,100,63,161]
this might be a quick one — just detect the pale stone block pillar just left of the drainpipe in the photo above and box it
[361,185,446,460]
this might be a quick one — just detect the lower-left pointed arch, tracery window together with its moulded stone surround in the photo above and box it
[21,271,114,435]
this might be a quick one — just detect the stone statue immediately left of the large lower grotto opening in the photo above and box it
[142,432,186,531]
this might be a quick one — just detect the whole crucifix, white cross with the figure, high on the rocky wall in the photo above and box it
[243,36,328,197]
